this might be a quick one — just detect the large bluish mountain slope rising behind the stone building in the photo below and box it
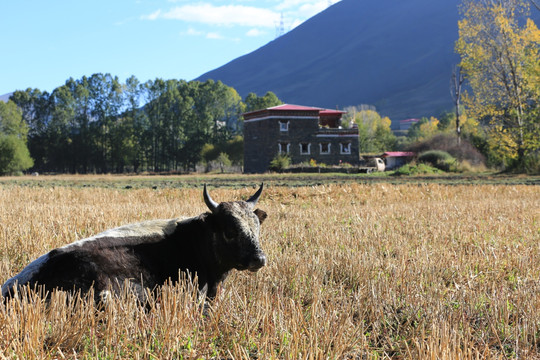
[196,0,459,121]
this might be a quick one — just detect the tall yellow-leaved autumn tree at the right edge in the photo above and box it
[456,0,540,162]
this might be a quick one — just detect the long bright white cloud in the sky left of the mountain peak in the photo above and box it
[148,3,280,27]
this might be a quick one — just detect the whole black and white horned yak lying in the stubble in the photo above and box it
[2,184,266,302]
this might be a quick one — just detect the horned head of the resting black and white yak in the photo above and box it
[203,184,266,271]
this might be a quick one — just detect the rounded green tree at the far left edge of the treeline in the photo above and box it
[0,101,34,175]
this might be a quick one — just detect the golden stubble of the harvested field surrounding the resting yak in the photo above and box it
[0,178,540,359]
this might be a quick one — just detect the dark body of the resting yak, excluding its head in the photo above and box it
[2,213,226,300]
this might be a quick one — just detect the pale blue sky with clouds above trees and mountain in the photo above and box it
[0,0,339,95]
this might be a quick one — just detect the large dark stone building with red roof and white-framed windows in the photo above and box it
[244,104,359,173]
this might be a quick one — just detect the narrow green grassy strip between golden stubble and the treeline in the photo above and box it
[0,173,540,189]
